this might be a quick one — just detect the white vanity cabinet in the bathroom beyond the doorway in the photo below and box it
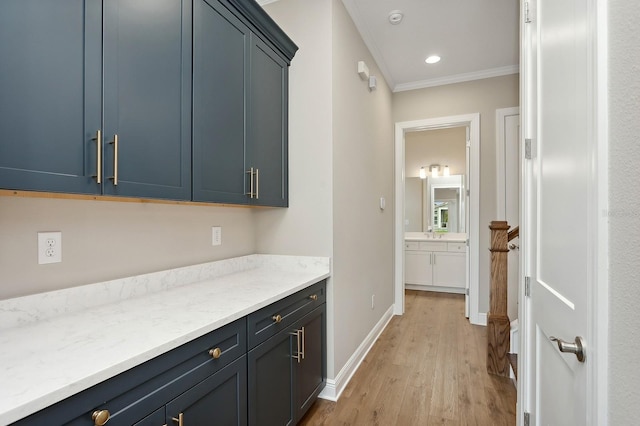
[404,241,466,292]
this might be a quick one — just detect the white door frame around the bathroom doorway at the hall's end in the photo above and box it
[393,113,486,325]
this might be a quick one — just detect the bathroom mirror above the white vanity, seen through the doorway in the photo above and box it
[405,175,465,232]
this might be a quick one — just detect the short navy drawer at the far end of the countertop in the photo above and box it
[247,280,326,349]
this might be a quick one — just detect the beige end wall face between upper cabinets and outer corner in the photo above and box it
[256,0,333,256]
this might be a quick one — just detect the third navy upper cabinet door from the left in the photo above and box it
[193,0,250,204]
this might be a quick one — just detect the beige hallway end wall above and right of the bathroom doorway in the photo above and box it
[393,74,519,312]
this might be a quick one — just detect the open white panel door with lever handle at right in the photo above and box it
[520,0,599,425]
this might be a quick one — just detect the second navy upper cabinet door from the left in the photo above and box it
[104,0,192,200]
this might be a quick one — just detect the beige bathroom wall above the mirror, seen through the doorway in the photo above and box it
[404,127,467,177]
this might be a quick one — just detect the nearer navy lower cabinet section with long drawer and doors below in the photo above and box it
[15,318,247,426]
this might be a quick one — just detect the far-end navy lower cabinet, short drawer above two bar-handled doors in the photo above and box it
[247,281,326,426]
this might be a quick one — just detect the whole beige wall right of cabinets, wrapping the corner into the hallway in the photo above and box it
[256,0,393,378]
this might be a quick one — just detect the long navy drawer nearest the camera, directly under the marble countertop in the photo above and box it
[16,318,247,426]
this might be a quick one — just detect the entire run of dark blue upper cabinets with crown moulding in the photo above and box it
[0,0,297,206]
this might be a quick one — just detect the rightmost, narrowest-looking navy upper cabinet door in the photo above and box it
[247,35,288,207]
